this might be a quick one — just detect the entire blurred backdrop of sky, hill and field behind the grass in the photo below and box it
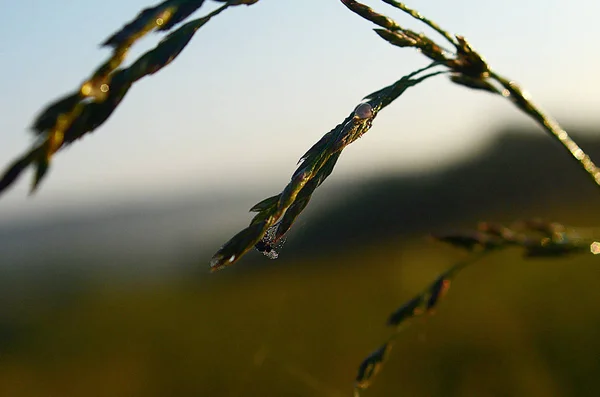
[0,0,600,397]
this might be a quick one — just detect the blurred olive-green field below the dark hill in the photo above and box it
[0,234,600,397]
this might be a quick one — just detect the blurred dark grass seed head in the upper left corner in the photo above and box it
[0,0,258,194]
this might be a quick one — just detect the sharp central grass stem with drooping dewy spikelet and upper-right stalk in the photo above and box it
[210,0,600,270]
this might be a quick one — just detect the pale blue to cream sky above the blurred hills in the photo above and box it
[0,0,600,222]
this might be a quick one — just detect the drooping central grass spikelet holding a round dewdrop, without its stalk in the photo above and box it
[210,63,443,270]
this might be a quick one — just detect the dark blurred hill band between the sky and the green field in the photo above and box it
[0,124,600,273]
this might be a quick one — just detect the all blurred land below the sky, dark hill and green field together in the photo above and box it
[0,132,600,397]
